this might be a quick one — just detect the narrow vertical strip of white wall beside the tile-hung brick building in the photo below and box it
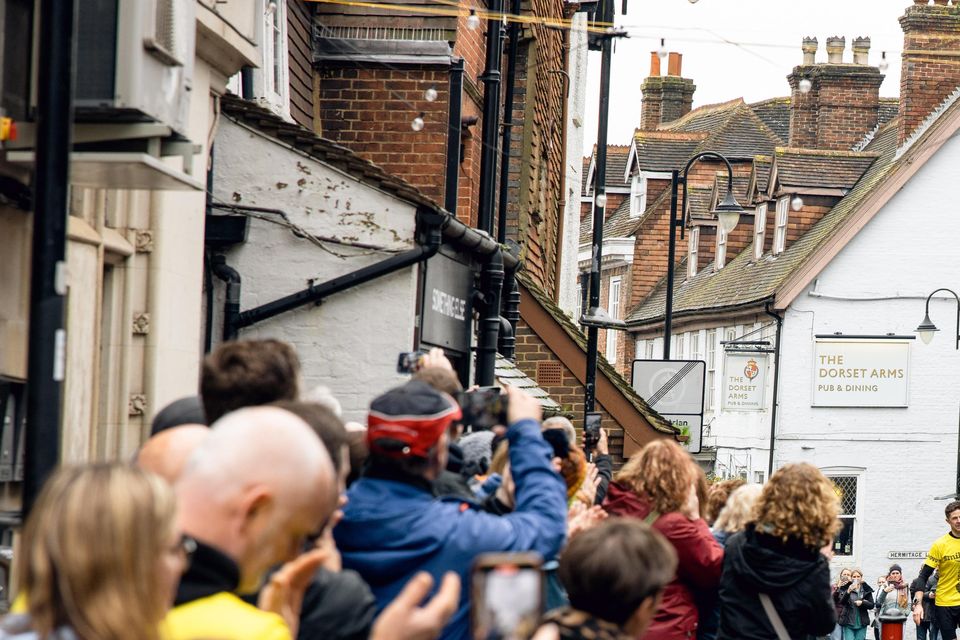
[557,12,587,316]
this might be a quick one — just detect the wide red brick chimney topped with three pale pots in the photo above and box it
[787,36,883,151]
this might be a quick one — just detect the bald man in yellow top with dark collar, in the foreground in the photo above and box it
[164,407,337,640]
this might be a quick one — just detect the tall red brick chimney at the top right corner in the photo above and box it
[899,0,960,143]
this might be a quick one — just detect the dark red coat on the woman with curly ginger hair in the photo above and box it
[603,482,723,640]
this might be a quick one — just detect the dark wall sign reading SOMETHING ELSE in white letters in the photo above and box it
[420,253,473,353]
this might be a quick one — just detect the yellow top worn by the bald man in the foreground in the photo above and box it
[160,592,292,640]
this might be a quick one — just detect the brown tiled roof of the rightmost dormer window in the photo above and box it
[774,147,877,189]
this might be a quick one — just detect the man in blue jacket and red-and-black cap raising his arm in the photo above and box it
[335,380,567,639]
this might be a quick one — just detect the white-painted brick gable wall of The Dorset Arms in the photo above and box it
[776,131,960,592]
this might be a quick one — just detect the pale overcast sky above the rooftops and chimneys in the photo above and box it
[584,0,912,148]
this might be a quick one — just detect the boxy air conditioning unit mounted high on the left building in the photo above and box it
[75,0,197,134]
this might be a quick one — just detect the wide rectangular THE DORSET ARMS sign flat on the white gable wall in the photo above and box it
[813,336,913,407]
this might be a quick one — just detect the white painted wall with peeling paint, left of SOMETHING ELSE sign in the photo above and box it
[214,117,418,422]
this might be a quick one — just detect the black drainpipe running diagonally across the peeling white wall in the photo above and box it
[233,209,444,332]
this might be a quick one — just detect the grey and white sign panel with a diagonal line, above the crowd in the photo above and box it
[633,360,707,453]
